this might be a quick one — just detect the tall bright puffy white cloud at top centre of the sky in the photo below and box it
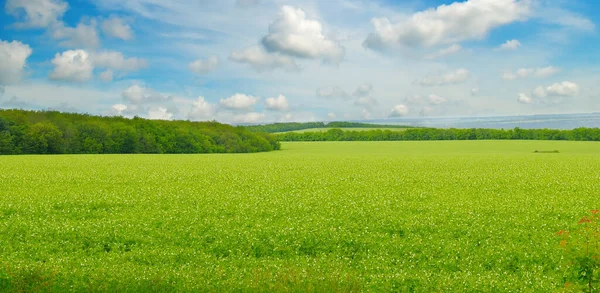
[262,6,344,64]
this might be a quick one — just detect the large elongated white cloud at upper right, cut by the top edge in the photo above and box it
[363,0,530,50]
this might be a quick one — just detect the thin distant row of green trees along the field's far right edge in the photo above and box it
[275,127,600,141]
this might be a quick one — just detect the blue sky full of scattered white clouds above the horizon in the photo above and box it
[0,0,600,123]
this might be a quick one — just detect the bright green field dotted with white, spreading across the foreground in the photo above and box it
[0,141,600,292]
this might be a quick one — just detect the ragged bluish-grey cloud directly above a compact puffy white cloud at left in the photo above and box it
[51,19,100,48]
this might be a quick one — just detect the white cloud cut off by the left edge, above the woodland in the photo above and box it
[0,40,32,85]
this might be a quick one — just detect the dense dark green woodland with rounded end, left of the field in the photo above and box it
[0,109,280,154]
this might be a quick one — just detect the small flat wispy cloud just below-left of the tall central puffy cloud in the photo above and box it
[229,46,300,72]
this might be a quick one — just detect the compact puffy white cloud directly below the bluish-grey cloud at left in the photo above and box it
[50,50,94,82]
